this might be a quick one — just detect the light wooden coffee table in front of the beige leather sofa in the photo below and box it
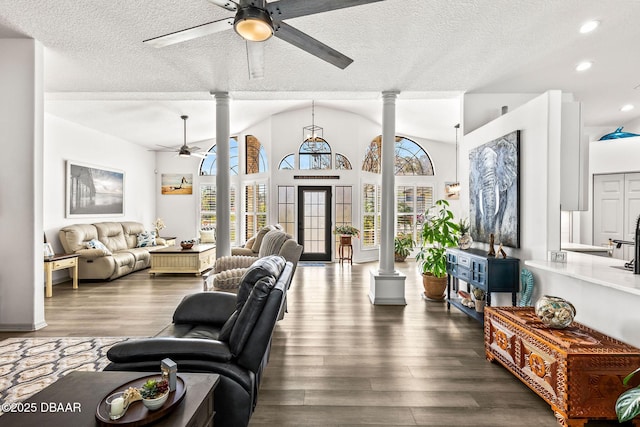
[149,243,216,276]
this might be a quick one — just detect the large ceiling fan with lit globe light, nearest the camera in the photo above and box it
[143,0,382,79]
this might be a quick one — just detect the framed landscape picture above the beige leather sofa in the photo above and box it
[66,160,124,218]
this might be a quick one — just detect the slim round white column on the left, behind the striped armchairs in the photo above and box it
[213,92,231,258]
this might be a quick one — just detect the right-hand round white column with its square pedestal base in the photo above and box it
[369,91,407,305]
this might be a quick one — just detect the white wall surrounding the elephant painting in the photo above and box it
[459,91,562,305]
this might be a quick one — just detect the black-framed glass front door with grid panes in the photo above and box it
[298,186,331,261]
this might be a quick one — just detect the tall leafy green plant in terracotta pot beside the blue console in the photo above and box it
[416,199,459,301]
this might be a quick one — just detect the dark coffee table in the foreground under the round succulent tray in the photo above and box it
[0,371,220,427]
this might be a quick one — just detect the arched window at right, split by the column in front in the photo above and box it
[362,136,433,176]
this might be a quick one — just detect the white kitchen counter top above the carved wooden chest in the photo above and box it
[524,252,640,296]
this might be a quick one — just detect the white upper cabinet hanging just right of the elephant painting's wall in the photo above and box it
[560,101,589,211]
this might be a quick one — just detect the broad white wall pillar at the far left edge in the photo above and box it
[0,39,46,331]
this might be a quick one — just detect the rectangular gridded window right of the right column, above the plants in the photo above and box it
[396,185,433,241]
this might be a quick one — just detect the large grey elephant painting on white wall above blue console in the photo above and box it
[469,131,520,248]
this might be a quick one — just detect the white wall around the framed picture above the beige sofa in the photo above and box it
[43,114,159,280]
